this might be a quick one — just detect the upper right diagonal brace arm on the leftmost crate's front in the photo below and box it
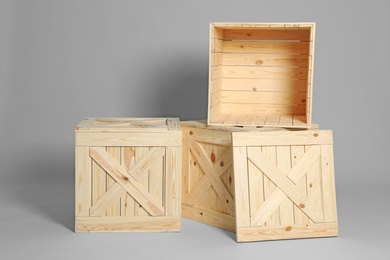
[128,147,165,180]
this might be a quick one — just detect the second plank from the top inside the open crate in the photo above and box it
[223,41,310,54]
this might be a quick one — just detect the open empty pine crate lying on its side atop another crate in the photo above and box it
[208,23,315,128]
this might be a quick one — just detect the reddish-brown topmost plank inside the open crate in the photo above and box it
[223,29,310,41]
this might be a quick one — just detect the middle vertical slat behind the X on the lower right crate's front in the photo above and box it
[276,145,294,225]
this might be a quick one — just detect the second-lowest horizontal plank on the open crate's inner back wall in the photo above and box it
[221,91,306,105]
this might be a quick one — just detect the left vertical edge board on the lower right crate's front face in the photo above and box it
[233,147,251,227]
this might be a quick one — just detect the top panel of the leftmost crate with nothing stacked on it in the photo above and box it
[75,118,181,133]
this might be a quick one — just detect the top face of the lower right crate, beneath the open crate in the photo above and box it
[181,119,319,133]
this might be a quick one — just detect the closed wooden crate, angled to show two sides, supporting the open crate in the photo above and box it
[182,121,338,242]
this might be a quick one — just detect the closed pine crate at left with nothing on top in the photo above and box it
[75,118,182,232]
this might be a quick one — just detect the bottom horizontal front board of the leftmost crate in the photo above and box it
[75,216,181,232]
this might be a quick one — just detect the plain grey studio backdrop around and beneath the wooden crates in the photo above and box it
[0,0,390,259]
